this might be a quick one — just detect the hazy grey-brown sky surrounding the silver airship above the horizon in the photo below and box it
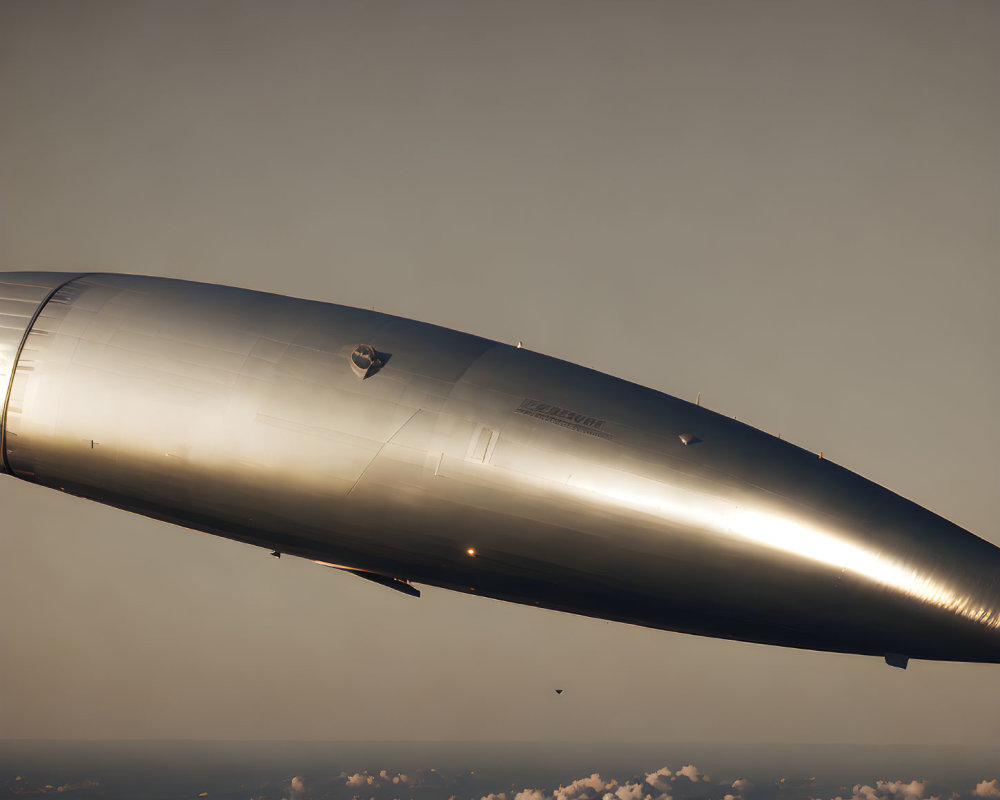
[0,0,1000,745]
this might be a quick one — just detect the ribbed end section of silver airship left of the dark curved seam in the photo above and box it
[0,272,84,472]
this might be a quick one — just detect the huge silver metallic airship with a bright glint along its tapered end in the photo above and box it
[0,272,1000,667]
